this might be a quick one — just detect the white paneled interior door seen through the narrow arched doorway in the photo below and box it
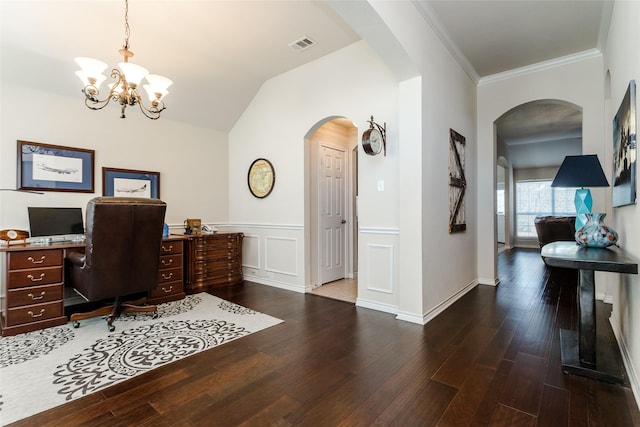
[318,144,346,284]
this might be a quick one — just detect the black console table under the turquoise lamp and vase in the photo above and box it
[541,242,638,383]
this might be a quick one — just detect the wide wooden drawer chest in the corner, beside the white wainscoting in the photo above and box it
[186,233,244,293]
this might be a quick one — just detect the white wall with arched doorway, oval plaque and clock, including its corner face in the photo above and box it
[229,2,478,323]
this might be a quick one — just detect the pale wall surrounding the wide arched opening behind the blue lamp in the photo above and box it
[477,56,611,283]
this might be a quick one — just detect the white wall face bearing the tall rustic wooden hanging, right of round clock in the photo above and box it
[373,2,479,321]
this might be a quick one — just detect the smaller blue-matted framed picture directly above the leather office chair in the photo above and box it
[102,167,160,199]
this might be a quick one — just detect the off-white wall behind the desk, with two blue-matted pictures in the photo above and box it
[0,83,228,231]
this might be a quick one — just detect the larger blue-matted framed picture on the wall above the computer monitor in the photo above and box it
[17,140,95,193]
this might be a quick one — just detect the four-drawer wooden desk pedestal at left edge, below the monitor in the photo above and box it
[1,248,67,336]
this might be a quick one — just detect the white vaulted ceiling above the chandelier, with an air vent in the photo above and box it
[0,0,359,132]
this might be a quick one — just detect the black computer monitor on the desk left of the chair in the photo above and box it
[27,207,84,240]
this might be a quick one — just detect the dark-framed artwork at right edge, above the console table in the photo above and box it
[611,80,636,208]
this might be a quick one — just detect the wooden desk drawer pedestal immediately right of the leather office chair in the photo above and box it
[149,237,185,304]
